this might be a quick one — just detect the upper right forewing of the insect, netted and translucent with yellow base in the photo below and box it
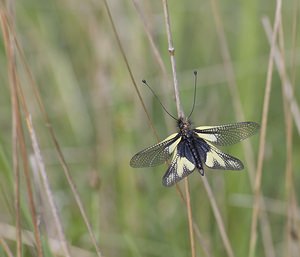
[194,121,260,145]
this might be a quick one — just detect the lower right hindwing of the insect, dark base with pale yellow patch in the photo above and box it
[197,139,244,170]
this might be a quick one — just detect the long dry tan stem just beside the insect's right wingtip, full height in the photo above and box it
[249,0,281,257]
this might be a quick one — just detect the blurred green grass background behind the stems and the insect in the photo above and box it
[0,0,300,257]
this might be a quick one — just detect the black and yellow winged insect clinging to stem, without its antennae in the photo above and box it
[130,118,259,186]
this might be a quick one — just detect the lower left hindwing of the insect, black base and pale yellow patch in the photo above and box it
[162,141,196,187]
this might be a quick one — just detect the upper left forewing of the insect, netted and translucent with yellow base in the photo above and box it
[130,133,181,168]
